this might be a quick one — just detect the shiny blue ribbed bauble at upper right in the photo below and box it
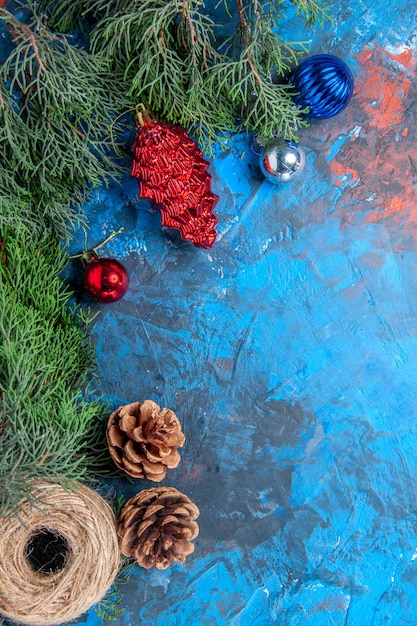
[291,54,354,119]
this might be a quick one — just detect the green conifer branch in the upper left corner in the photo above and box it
[0,4,128,237]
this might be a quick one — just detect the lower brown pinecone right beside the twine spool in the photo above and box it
[117,487,200,569]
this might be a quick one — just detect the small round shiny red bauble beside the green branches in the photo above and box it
[84,256,129,302]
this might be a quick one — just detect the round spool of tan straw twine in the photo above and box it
[0,482,120,626]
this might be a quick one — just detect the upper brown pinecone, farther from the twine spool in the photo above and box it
[107,400,185,482]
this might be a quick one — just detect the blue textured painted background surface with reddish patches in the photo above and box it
[8,0,417,626]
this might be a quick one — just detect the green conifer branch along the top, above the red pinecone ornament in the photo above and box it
[34,0,330,152]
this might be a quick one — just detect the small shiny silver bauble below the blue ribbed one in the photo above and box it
[260,138,306,183]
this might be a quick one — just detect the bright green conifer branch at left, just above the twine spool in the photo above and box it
[0,235,108,517]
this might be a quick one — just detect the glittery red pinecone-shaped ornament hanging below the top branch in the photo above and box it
[132,106,218,249]
